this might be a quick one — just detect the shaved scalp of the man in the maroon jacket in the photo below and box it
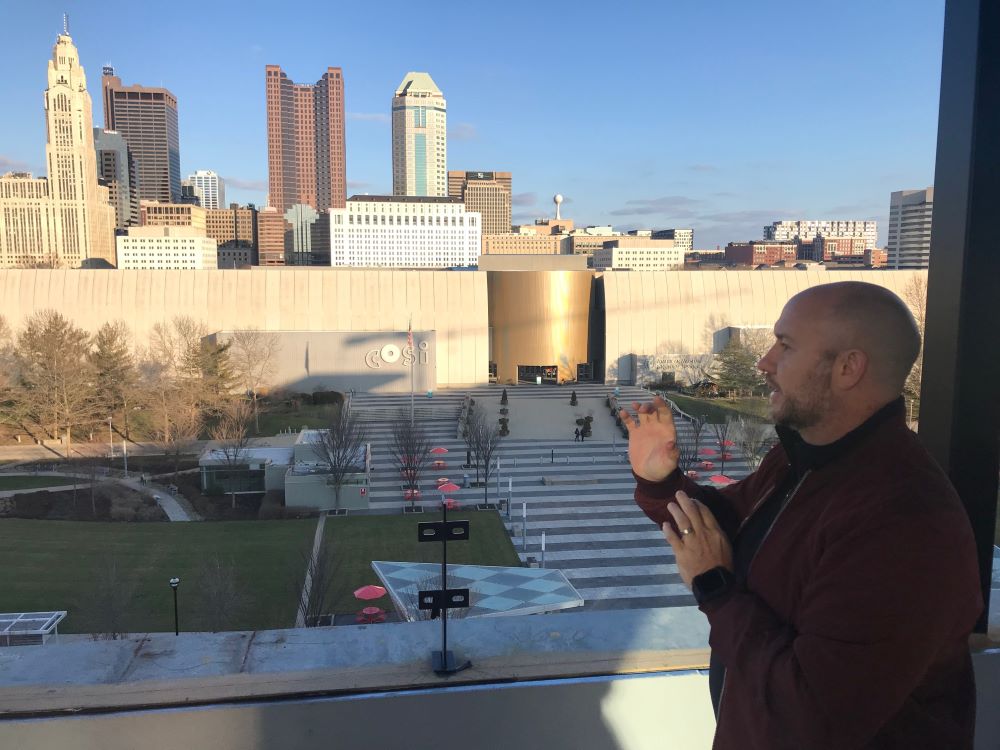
[789,281,920,395]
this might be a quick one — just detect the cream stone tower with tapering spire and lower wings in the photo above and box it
[0,28,115,268]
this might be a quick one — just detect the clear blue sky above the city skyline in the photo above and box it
[0,0,944,248]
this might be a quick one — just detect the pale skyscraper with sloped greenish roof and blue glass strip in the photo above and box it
[392,73,448,197]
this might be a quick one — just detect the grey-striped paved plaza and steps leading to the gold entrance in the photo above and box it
[353,385,747,609]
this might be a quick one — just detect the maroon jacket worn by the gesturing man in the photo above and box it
[635,410,983,750]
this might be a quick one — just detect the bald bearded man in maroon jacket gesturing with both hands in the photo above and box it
[625,282,982,750]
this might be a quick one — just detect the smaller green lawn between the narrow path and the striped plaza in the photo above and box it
[325,511,521,614]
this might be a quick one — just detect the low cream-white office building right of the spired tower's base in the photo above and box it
[116,226,219,271]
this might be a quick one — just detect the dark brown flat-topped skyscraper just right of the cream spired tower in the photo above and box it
[101,66,181,203]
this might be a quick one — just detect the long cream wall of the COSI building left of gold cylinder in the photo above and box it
[0,267,489,387]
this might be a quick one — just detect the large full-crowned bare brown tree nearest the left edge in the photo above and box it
[14,310,98,459]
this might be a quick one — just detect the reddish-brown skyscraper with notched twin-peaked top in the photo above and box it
[265,65,347,215]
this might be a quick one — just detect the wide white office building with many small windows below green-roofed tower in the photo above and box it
[330,195,482,268]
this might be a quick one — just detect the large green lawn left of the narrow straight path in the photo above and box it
[0,519,316,633]
